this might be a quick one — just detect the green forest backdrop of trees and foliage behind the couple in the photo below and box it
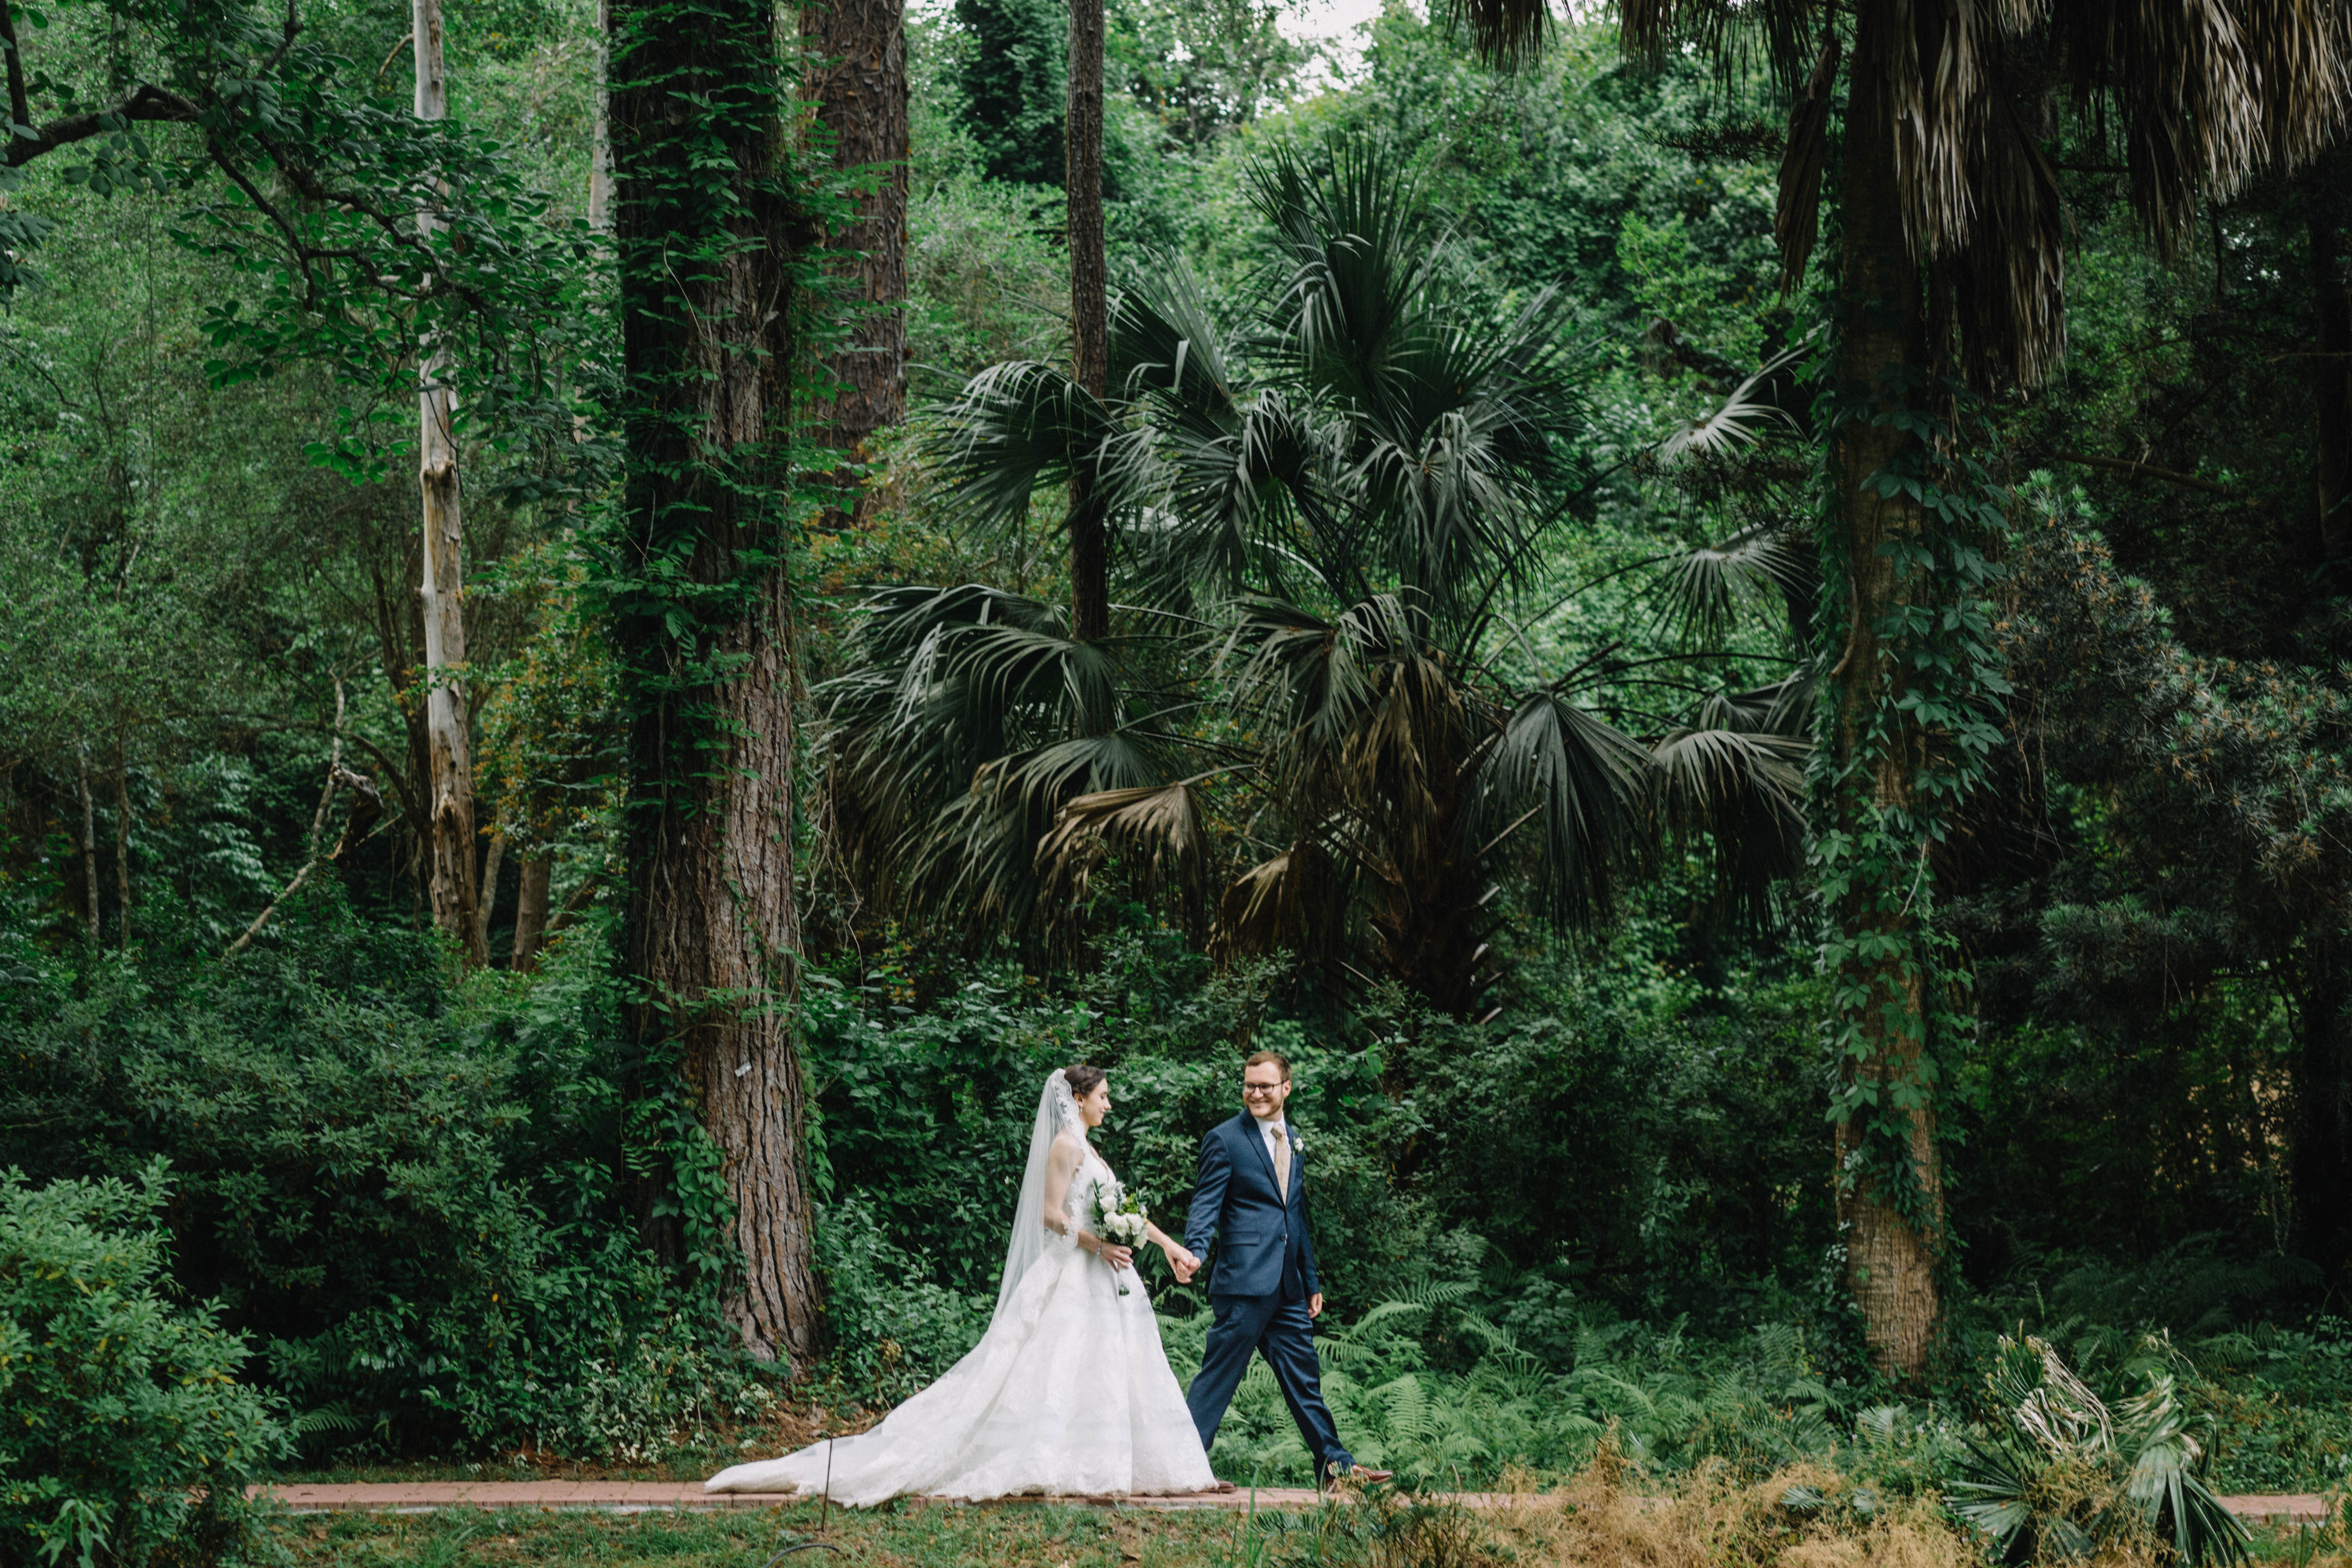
[0,0,2352,1551]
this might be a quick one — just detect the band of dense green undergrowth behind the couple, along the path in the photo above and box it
[0,894,2352,1493]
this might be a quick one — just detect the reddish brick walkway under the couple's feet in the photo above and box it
[252,1481,2328,1526]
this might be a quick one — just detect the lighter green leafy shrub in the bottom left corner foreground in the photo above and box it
[0,1159,287,1568]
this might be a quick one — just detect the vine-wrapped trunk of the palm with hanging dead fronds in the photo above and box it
[1830,15,1943,1378]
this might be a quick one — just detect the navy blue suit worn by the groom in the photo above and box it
[1183,1112,1355,1472]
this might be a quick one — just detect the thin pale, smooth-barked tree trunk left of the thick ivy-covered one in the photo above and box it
[412,0,489,969]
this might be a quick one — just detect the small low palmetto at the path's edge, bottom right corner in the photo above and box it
[1950,1335,2246,1568]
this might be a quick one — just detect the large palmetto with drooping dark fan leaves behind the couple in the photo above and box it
[830,141,1802,1015]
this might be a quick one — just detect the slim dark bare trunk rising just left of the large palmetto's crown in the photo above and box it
[1063,0,1110,642]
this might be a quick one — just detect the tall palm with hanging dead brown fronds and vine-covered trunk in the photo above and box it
[1468,0,2345,1378]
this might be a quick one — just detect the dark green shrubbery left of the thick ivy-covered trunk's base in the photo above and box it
[0,889,767,1460]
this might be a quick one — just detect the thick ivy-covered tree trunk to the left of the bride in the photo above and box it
[609,0,819,1363]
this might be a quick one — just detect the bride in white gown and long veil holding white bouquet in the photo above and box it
[703,1067,1218,1507]
